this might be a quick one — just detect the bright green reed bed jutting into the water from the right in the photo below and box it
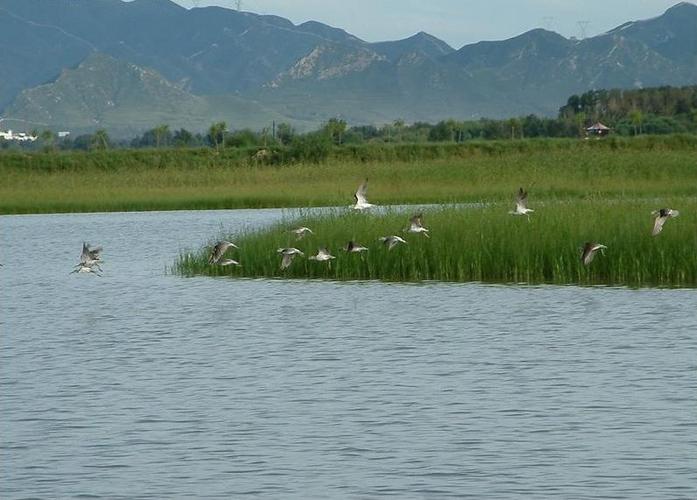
[173,198,697,287]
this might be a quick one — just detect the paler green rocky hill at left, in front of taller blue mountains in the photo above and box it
[6,52,302,137]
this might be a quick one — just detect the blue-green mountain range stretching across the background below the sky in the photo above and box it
[0,0,697,135]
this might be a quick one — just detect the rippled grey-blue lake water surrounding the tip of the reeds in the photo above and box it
[0,210,697,499]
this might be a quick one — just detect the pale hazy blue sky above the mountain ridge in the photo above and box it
[169,0,678,48]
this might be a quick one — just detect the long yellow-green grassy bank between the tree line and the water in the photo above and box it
[0,136,697,214]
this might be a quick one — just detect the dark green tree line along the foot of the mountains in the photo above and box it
[5,85,697,154]
